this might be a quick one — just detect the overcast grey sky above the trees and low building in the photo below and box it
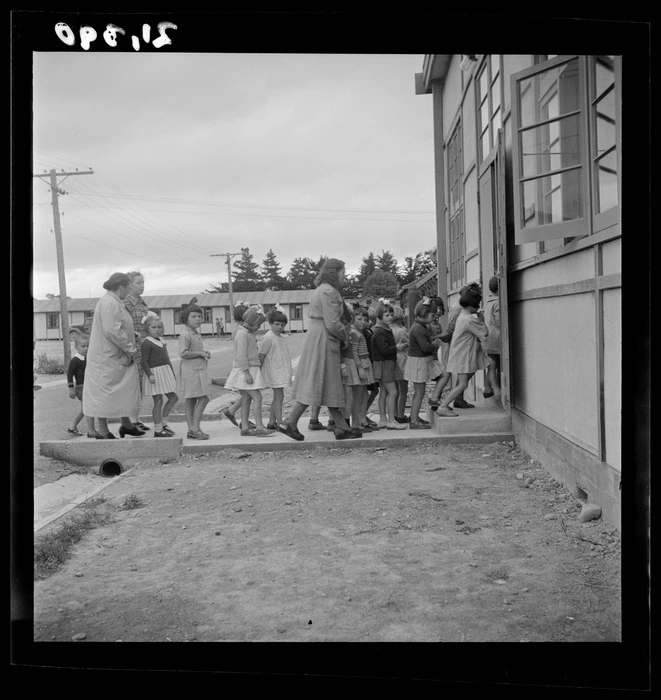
[33,52,435,299]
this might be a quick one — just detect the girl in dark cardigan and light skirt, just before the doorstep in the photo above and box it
[404,297,443,430]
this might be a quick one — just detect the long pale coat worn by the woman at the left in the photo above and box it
[83,291,140,418]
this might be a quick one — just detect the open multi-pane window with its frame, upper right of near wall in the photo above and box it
[512,56,620,244]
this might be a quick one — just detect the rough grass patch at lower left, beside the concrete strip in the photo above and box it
[34,499,113,580]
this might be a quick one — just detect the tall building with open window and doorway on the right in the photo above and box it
[414,55,622,527]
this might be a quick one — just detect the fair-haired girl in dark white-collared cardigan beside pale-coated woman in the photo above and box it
[141,316,179,437]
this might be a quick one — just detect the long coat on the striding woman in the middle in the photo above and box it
[293,282,349,408]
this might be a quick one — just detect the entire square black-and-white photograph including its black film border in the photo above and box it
[10,11,651,689]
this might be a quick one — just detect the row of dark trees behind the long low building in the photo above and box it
[204,248,436,297]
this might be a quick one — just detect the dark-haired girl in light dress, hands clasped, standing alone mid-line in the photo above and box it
[177,304,211,440]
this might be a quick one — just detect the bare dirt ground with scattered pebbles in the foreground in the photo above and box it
[34,443,622,643]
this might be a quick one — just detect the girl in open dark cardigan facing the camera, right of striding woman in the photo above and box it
[372,299,406,430]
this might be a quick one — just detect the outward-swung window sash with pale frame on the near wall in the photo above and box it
[511,55,592,245]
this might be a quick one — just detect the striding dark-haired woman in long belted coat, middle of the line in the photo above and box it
[283,258,361,440]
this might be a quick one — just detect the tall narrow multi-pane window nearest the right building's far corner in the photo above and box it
[447,122,466,289]
